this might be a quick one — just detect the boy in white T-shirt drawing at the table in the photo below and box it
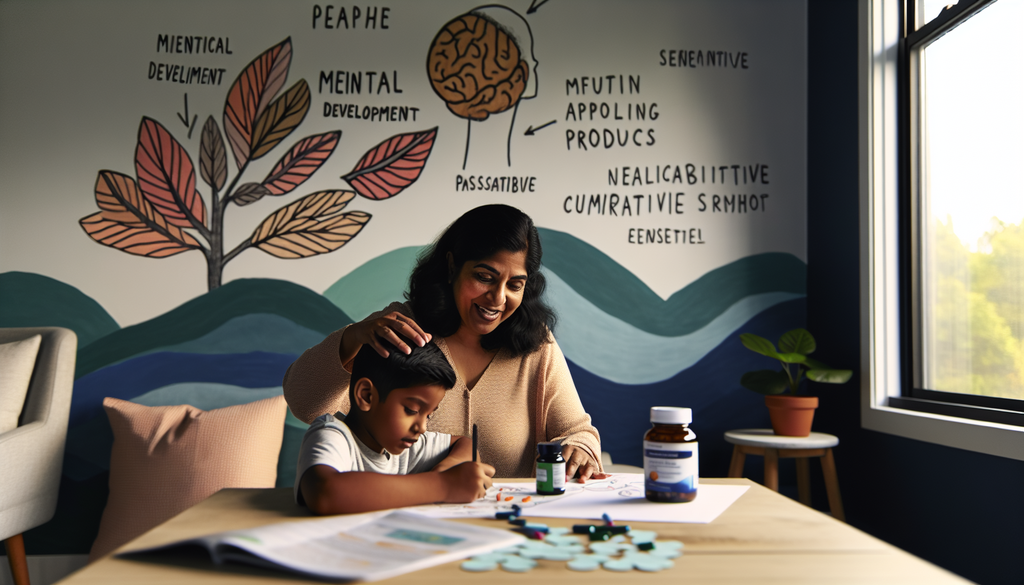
[295,336,495,514]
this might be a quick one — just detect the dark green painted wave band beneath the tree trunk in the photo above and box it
[75,279,352,378]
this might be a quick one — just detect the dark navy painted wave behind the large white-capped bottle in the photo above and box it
[568,298,806,477]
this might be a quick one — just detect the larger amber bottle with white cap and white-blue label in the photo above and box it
[643,407,697,503]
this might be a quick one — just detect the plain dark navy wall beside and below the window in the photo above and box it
[807,0,1024,584]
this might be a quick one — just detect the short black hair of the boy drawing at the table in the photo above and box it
[348,340,455,405]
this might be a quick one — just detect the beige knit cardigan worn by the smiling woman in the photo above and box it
[284,303,601,477]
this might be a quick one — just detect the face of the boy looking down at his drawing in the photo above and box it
[360,384,444,455]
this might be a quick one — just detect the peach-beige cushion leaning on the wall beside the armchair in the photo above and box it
[89,395,287,560]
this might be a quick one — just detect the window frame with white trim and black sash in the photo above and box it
[858,0,1024,460]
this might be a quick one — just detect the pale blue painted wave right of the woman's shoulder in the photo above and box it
[543,268,804,384]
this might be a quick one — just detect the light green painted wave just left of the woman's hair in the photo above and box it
[324,246,424,321]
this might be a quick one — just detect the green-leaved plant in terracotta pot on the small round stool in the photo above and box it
[739,329,853,436]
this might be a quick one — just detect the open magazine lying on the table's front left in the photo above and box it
[121,511,523,581]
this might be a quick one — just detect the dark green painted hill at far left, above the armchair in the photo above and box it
[0,271,121,347]
